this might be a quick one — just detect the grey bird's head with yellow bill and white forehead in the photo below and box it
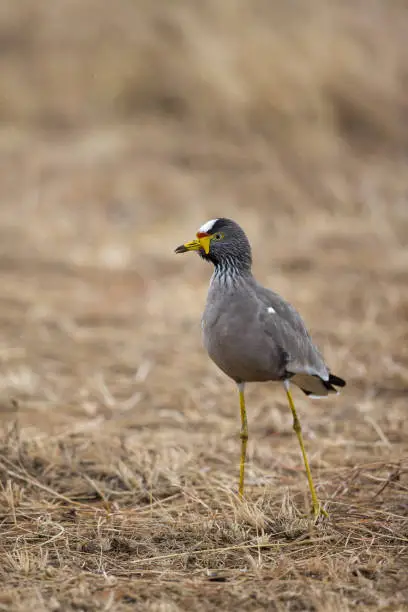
[175,218,252,269]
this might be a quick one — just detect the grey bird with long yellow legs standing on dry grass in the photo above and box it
[175,217,346,520]
